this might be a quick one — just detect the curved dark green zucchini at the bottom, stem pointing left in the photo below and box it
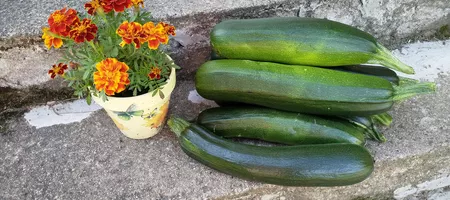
[168,117,374,186]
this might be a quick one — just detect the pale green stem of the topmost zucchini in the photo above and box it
[367,43,415,74]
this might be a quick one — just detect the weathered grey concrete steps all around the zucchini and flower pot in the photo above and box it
[0,0,450,199]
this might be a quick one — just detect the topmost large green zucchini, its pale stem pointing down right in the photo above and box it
[210,17,414,74]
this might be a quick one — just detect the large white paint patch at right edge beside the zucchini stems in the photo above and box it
[393,40,450,81]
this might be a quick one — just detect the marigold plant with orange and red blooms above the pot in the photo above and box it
[42,0,179,103]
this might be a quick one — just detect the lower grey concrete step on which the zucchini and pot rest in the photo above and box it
[0,38,450,199]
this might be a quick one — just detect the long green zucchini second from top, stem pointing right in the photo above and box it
[195,60,435,116]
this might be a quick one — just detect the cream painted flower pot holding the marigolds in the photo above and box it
[92,68,176,139]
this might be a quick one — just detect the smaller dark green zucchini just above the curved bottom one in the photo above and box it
[197,106,365,145]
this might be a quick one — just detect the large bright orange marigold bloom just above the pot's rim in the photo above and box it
[94,58,130,96]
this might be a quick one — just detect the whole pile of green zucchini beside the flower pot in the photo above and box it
[168,17,435,186]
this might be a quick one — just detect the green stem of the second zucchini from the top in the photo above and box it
[392,82,436,101]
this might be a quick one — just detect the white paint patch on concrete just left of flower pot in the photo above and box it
[24,99,102,128]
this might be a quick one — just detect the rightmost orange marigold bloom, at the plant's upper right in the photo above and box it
[142,22,169,49]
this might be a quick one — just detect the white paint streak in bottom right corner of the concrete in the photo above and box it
[394,176,450,199]
